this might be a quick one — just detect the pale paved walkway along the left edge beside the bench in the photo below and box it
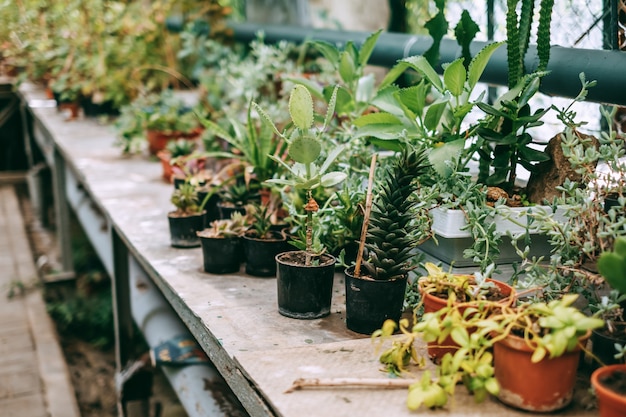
[0,185,80,417]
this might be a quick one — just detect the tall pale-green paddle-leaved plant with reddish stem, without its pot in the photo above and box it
[252,84,346,266]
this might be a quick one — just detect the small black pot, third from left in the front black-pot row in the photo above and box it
[243,232,289,277]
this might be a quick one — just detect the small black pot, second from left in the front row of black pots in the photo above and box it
[200,236,242,274]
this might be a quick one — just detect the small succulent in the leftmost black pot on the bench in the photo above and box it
[167,182,204,248]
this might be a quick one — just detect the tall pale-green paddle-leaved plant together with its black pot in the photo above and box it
[253,84,346,319]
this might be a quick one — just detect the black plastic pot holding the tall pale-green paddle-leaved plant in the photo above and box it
[276,251,336,319]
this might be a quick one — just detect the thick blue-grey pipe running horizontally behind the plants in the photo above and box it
[231,23,626,105]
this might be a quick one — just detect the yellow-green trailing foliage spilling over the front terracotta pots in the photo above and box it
[372,294,604,410]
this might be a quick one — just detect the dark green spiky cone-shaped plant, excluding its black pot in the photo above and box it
[363,146,429,280]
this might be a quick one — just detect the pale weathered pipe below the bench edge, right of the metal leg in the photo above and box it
[129,255,247,417]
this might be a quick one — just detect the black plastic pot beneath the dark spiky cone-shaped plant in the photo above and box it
[344,267,407,334]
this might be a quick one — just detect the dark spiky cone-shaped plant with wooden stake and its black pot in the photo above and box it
[345,144,430,334]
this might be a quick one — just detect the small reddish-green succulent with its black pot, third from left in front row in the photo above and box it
[242,204,288,277]
